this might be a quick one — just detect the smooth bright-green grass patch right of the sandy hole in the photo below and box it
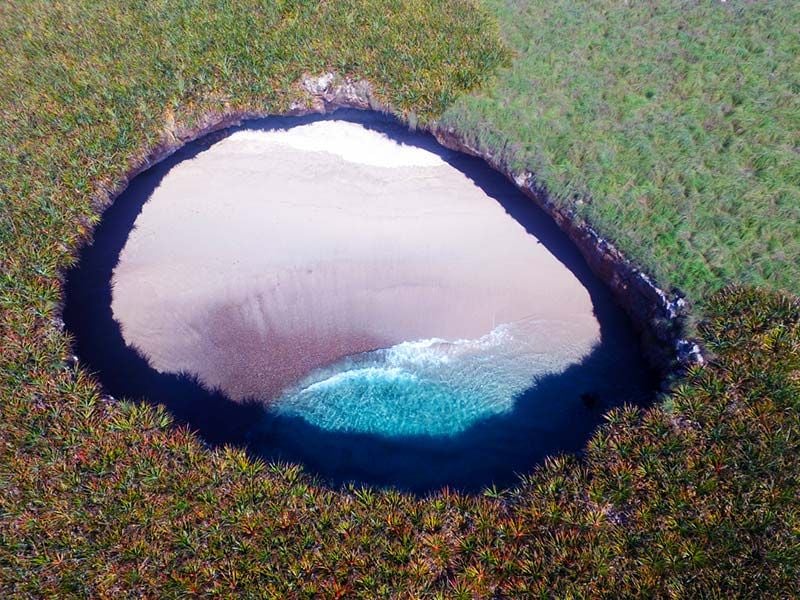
[444,0,800,301]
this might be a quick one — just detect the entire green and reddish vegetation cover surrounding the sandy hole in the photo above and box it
[0,0,800,598]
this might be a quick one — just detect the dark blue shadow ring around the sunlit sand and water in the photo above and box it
[63,111,657,493]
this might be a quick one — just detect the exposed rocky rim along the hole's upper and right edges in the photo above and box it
[94,73,704,375]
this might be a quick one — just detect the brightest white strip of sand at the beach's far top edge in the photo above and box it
[228,121,445,168]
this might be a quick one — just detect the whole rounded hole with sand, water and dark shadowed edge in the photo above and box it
[64,111,656,493]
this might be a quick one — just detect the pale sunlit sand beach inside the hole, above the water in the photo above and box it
[112,121,599,399]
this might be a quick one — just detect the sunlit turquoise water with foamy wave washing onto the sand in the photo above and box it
[271,319,592,437]
